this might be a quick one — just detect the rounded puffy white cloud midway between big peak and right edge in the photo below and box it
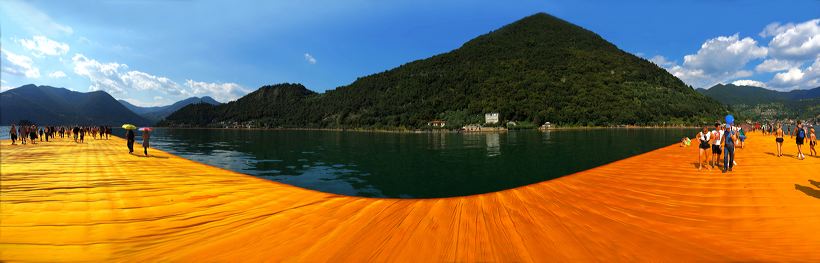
[683,34,767,74]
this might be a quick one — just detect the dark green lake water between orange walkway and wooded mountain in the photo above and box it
[0,127,697,198]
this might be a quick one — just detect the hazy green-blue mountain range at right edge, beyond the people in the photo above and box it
[697,84,820,120]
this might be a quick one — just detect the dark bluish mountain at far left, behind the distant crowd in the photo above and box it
[0,84,150,126]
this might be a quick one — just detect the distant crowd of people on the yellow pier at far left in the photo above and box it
[9,124,111,145]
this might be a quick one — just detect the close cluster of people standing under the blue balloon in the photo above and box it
[696,122,746,173]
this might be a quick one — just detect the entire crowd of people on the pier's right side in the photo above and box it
[681,116,817,173]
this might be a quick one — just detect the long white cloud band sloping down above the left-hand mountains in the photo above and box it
[72,54,249,102]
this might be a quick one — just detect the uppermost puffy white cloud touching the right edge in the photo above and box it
[761,19,820,60]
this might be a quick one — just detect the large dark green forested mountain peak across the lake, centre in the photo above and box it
[163,13,725,128]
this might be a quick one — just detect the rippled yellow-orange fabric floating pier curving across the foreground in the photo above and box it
[0,134,820,262]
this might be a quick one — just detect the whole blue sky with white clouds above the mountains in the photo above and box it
[0,0,820,106]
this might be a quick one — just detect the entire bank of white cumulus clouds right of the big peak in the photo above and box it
[649,19,820,90]
